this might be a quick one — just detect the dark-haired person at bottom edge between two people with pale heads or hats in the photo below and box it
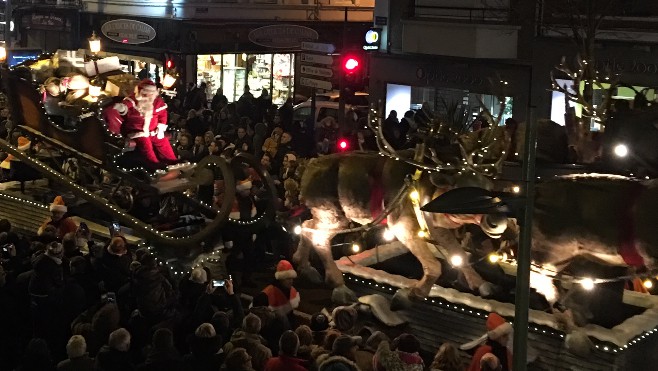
[137,328,185,371]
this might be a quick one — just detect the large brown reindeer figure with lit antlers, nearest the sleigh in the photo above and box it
[293,102,506,309]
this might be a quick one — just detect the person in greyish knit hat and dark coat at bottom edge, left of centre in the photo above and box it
[183,323,226,371]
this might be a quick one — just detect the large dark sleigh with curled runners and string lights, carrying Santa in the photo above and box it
[0,62,275,254]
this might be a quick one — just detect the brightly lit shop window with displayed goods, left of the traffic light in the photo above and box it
[197,53,294,105]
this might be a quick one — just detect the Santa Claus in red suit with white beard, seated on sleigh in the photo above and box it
[104,79,177,169]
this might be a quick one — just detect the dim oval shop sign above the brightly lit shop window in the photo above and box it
[249,24,319,48]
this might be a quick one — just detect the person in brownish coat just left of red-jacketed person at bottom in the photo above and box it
[224,314,272,370]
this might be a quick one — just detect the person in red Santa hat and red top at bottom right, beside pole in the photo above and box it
[460,313,513,371]
